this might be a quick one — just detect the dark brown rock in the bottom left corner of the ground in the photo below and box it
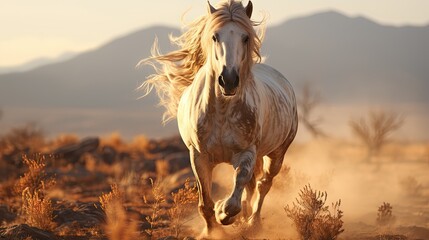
[0,224,59,240]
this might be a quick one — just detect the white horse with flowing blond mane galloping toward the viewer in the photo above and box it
[142,0,298,236]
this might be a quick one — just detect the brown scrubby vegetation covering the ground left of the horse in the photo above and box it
[0,126,196,239]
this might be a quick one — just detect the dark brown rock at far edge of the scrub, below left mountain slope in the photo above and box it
[53,137,100,163]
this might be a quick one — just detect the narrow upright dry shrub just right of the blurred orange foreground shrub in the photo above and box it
[143,178,165,238]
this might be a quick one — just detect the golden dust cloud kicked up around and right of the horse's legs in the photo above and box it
[201,138,429,239]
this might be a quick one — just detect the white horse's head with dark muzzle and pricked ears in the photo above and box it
[203,1,259,96]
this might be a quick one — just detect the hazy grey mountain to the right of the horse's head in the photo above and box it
[264,12,429,104]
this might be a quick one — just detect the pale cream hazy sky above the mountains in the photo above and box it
[0,0,429,66]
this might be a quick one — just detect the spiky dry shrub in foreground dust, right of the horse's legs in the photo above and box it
[285,185,344,240]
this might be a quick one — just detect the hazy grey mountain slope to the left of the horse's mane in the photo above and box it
[0,26,179,137]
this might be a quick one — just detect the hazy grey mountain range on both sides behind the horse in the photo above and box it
[0,12,429,137]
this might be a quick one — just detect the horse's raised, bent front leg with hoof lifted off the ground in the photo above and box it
[215,146,256,225]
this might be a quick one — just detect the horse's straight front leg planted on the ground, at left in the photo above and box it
[189,147,217,238]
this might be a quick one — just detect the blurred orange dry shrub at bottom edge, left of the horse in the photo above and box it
[99,184,138,240]
